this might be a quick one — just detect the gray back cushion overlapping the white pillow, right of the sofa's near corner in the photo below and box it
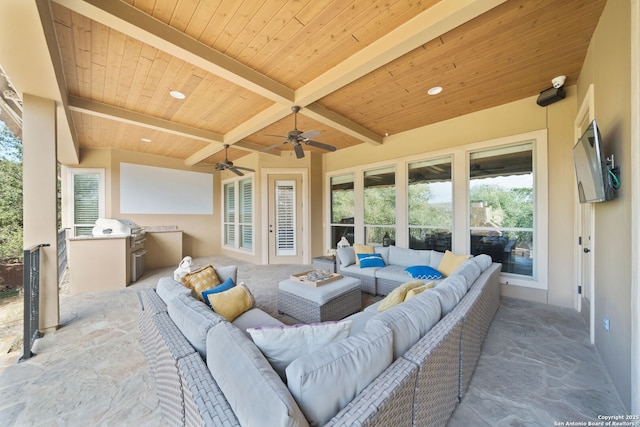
[286,327,393,426]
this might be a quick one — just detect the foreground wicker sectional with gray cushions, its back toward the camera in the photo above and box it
[138,255,501,427]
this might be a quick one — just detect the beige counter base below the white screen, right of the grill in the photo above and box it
[139,225,183,269]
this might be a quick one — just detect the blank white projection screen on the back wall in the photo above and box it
[120,163,213,215]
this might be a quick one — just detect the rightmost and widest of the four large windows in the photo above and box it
[469,143,537,277]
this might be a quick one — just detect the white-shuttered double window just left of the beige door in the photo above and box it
[222,178,254,250]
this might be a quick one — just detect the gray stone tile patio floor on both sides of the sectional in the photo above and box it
[0,263,627,427]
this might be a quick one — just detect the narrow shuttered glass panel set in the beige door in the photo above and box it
[275,181,296,255]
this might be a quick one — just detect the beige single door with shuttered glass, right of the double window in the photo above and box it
[268,175,303,264]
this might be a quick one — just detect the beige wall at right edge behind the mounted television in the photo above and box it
[578,1,638,408]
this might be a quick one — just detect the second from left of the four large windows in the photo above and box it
[364,166,396,245]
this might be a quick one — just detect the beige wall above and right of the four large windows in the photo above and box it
[325,91,577,308]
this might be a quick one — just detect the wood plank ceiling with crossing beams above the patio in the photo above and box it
[45,0,606,164]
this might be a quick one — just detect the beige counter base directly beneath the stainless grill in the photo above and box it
[68,235,131,294]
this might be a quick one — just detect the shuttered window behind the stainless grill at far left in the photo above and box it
[73,173,100,236]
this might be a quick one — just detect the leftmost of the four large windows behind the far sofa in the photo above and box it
[329,174,355,248]
